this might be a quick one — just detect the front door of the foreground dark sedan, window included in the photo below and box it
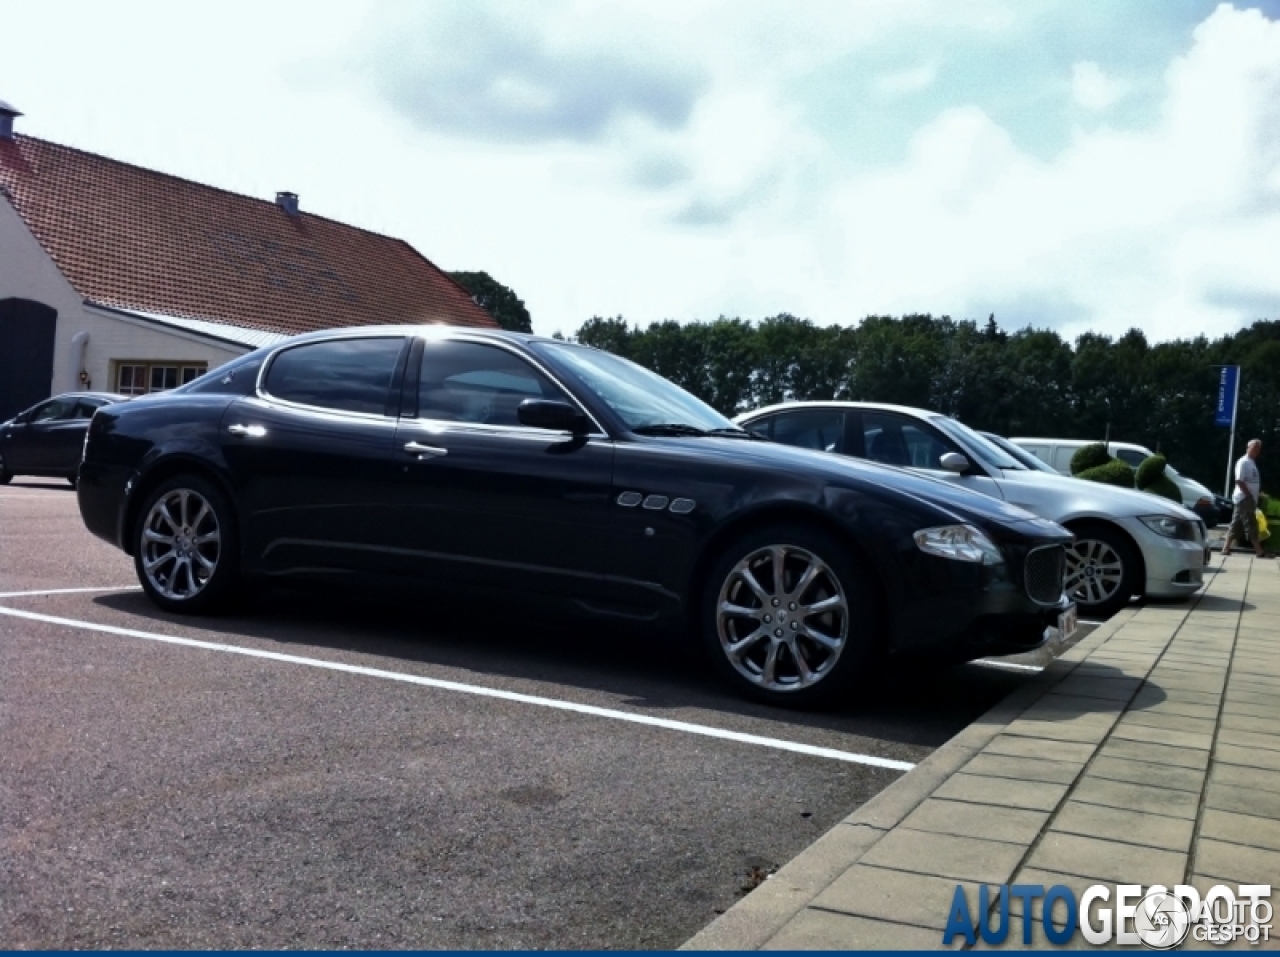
[396,338,613,597]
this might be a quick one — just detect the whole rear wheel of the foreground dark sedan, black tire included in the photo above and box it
[133,475,239,614]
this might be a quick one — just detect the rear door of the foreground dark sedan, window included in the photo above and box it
[219,335,408,573]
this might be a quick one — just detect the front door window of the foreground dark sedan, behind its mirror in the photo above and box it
[417,340,566,425]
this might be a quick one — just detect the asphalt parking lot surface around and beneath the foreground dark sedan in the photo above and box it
[0,480,1100,949]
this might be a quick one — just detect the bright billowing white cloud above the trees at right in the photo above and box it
[814,6,1280,339]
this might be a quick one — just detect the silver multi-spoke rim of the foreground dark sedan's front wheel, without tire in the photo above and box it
[716,545,849,692]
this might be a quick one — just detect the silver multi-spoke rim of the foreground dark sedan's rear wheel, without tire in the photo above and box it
[141,489,221,601]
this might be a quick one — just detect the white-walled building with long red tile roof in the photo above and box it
[0,101,495,420]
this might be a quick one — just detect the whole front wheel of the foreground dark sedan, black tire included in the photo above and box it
[698,523,881,708]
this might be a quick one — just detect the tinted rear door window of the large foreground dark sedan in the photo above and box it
[265,338,404,416]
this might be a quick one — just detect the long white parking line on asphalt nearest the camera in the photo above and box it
[0,606,915,771]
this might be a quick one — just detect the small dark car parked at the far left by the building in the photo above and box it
[0,392,124,485]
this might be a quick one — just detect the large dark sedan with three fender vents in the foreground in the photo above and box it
[78,326,1070,705]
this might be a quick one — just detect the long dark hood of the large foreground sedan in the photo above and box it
[644,436,1057,531]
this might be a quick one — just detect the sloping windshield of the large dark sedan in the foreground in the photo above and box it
[538,343,742,435]
